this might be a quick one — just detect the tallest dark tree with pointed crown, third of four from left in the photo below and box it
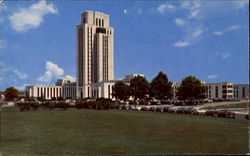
[150,72,173,99]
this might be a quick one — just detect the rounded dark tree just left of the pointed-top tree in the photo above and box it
[130,76,149,99]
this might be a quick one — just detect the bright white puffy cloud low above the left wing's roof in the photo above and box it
[37,61,64,83]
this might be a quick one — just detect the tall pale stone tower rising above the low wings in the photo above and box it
[76,11,114,98]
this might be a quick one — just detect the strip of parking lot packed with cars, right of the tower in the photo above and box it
[111,100,249,120]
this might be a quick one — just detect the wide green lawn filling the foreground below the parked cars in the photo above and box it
[1,108,248,156]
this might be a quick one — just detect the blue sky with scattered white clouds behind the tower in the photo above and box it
[0,0,249,90]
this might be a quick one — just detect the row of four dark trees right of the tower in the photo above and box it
[113,72,206,100]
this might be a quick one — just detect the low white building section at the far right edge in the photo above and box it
[233,84,249,99]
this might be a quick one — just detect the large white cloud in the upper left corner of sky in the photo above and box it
[9,1,57,32]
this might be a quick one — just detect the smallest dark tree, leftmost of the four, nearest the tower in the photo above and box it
[112,81,130,100]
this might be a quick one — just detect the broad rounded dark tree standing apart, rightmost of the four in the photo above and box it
[177,76,206,101]
